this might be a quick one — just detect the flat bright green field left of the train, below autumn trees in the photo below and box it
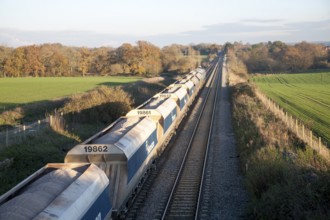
[0,77,141,110]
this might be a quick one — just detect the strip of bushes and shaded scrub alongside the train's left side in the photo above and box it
[0,78,173,195]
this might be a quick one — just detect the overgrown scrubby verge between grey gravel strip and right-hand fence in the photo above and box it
[232,83,330,219]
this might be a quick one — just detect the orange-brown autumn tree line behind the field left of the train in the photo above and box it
[0,41,221,77]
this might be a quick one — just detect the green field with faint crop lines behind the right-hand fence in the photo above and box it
[252,72,330,143]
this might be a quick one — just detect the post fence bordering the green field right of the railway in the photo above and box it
[256,90,330,160]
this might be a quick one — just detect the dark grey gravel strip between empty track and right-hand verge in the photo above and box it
[208,63,248,219]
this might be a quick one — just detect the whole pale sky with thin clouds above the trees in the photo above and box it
[0,0,330,47]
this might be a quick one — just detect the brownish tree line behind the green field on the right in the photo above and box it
[224,41,330,73]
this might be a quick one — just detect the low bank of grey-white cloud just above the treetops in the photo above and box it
[0,19,330,47]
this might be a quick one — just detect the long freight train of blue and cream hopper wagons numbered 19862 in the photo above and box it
[0,68,206,220]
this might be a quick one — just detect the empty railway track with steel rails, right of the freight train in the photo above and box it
[162,60,220,219]
